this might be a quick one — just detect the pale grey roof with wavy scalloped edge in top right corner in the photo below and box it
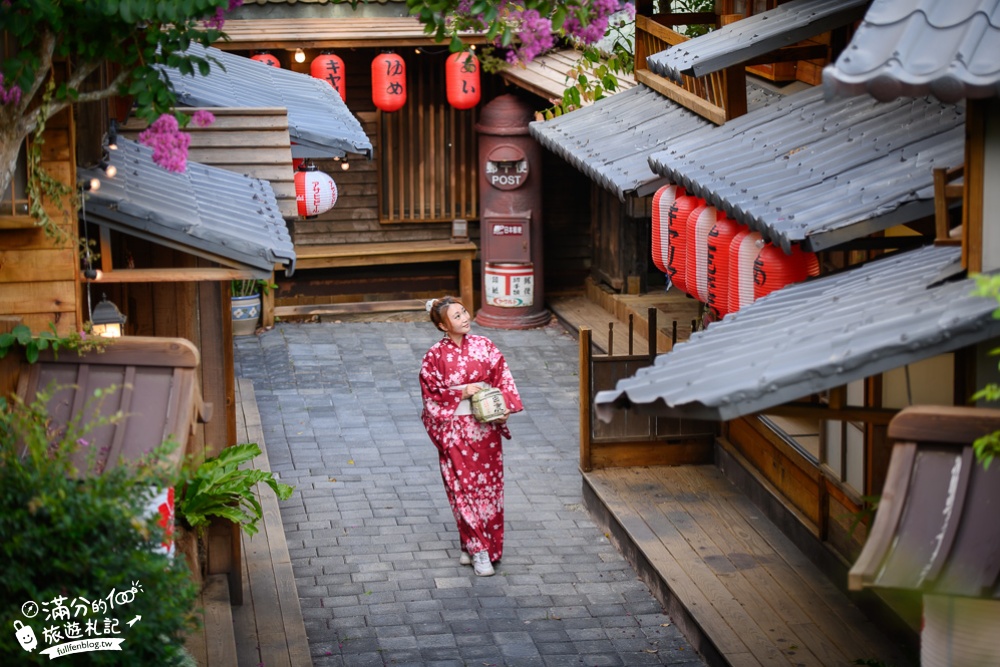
[823,0,1000,102]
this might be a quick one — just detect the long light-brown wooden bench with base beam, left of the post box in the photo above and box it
[263,239,478,326]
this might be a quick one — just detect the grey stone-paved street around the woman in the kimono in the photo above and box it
[236,321,704,667]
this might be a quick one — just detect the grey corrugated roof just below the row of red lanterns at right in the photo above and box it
[595,246,1000,420]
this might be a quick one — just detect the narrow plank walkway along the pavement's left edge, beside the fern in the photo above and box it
[188,379,312,667]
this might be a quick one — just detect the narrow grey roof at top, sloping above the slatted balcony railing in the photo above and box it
[646,0,868,83]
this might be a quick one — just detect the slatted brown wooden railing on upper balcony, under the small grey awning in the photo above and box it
[635,14,747,125]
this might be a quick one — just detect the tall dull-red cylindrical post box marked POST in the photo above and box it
[476,95,551,329]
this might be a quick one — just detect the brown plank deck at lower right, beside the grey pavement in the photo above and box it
[583,465,910,667]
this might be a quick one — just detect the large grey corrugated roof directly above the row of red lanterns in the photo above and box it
[649,88,965,252]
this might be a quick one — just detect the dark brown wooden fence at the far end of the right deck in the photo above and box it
[580,308,718,472]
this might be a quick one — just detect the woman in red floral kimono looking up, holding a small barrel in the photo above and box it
[420,296,522,577]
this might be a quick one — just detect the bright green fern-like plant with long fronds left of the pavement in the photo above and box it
[177,442,295,535]
